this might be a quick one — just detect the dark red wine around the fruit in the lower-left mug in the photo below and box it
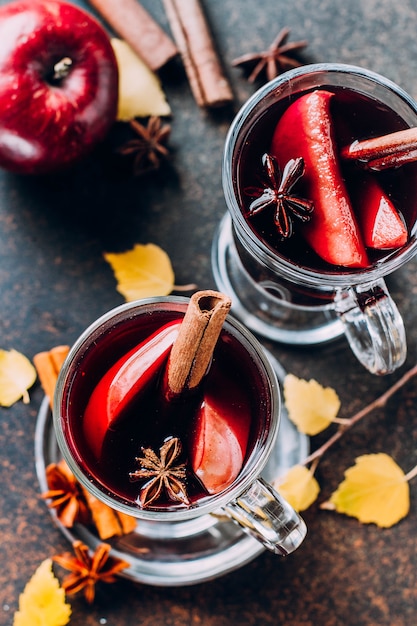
[62,311,271,509]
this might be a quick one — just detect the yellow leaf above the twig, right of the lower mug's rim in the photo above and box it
[284,374,340,436]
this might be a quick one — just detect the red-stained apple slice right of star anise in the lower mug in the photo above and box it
[189,370,252,494]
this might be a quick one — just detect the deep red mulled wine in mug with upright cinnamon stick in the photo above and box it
[60,305,273,511]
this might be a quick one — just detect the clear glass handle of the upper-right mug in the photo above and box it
[335,279,407,375]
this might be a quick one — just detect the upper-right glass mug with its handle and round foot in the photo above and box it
[212,63,417,374]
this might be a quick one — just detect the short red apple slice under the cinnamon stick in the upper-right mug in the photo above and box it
[355,173,408,250]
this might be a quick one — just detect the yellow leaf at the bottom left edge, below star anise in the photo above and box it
[13,559,71,626]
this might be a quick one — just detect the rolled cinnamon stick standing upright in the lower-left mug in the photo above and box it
[166,289,232,398]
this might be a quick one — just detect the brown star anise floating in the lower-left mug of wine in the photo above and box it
[129,437,189,508]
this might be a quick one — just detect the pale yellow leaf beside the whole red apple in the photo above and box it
[111,38,171,121]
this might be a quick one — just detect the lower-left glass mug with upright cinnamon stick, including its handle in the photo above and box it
[53,296,306,555]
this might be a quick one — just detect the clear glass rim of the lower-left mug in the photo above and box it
[53,296,282,522]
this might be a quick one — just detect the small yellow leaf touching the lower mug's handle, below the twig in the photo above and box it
[274,465,320,511]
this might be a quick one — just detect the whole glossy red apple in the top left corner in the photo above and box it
[0,0,118,174]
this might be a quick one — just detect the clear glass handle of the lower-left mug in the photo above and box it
[223,478,307,556]
